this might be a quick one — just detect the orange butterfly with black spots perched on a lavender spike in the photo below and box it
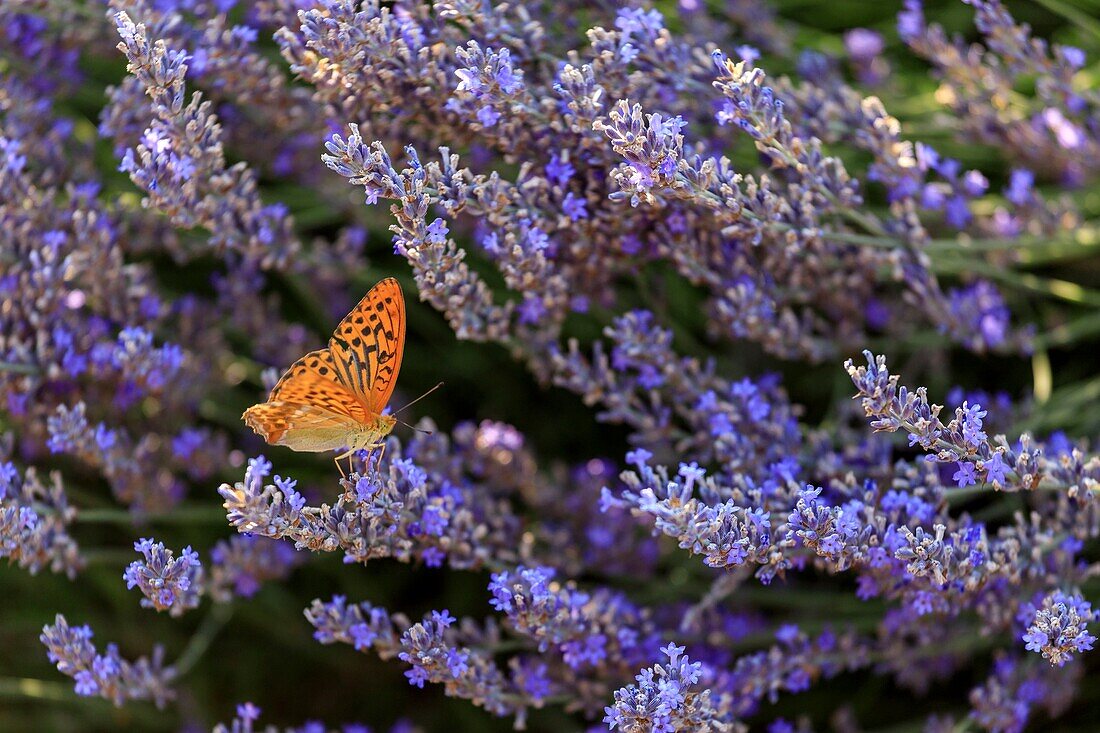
[241,277,405,475]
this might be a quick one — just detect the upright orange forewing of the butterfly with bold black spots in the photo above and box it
[330,277,405,414]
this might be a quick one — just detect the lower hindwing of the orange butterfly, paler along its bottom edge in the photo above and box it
[243,372,366,452]
